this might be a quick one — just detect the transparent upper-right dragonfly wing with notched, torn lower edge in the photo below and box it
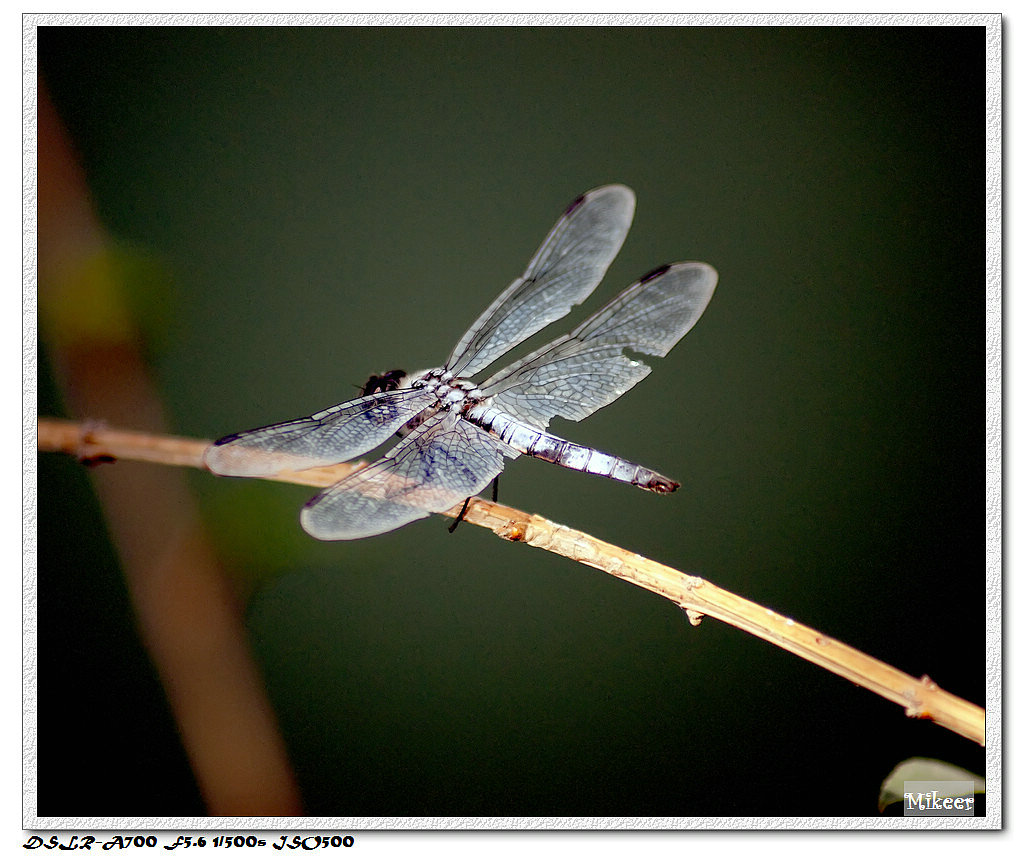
[480,262,718,429]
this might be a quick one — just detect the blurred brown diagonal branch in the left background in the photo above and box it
[38,81,302,816]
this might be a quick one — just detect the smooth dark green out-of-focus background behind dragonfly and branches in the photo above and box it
[38,28,985,816]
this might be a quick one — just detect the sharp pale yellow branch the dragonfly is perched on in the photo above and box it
[39,419,985,745]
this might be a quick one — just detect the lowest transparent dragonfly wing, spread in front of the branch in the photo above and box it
[300,411,518,541]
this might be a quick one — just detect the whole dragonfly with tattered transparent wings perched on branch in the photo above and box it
[205,184,718,541]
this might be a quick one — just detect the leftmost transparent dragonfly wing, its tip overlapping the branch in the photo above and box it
[204,389,437,476]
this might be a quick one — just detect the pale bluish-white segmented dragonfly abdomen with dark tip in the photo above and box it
[466,406,679,494]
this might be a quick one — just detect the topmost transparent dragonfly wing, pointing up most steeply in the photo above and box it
[445,184,636,378]
